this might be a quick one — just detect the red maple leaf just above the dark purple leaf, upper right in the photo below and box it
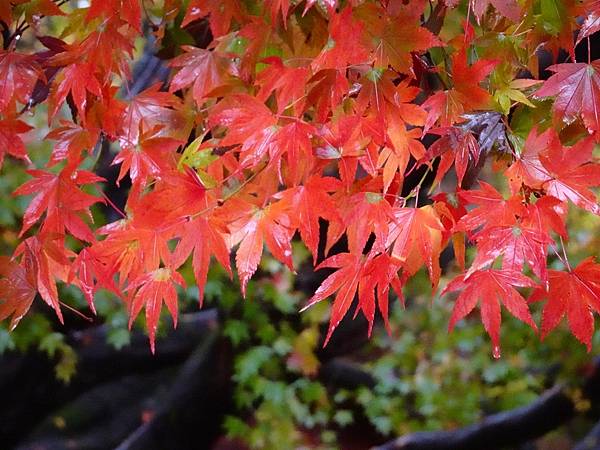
[423,48,498,131]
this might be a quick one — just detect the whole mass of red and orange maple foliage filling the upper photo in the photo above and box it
[0,0,600,356]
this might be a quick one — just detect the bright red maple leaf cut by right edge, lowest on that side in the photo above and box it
[530,258,600,352]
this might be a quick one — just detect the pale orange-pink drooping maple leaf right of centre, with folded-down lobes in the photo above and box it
[386,206,445,287]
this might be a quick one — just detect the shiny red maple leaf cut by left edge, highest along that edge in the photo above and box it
[0,50,44,112]
